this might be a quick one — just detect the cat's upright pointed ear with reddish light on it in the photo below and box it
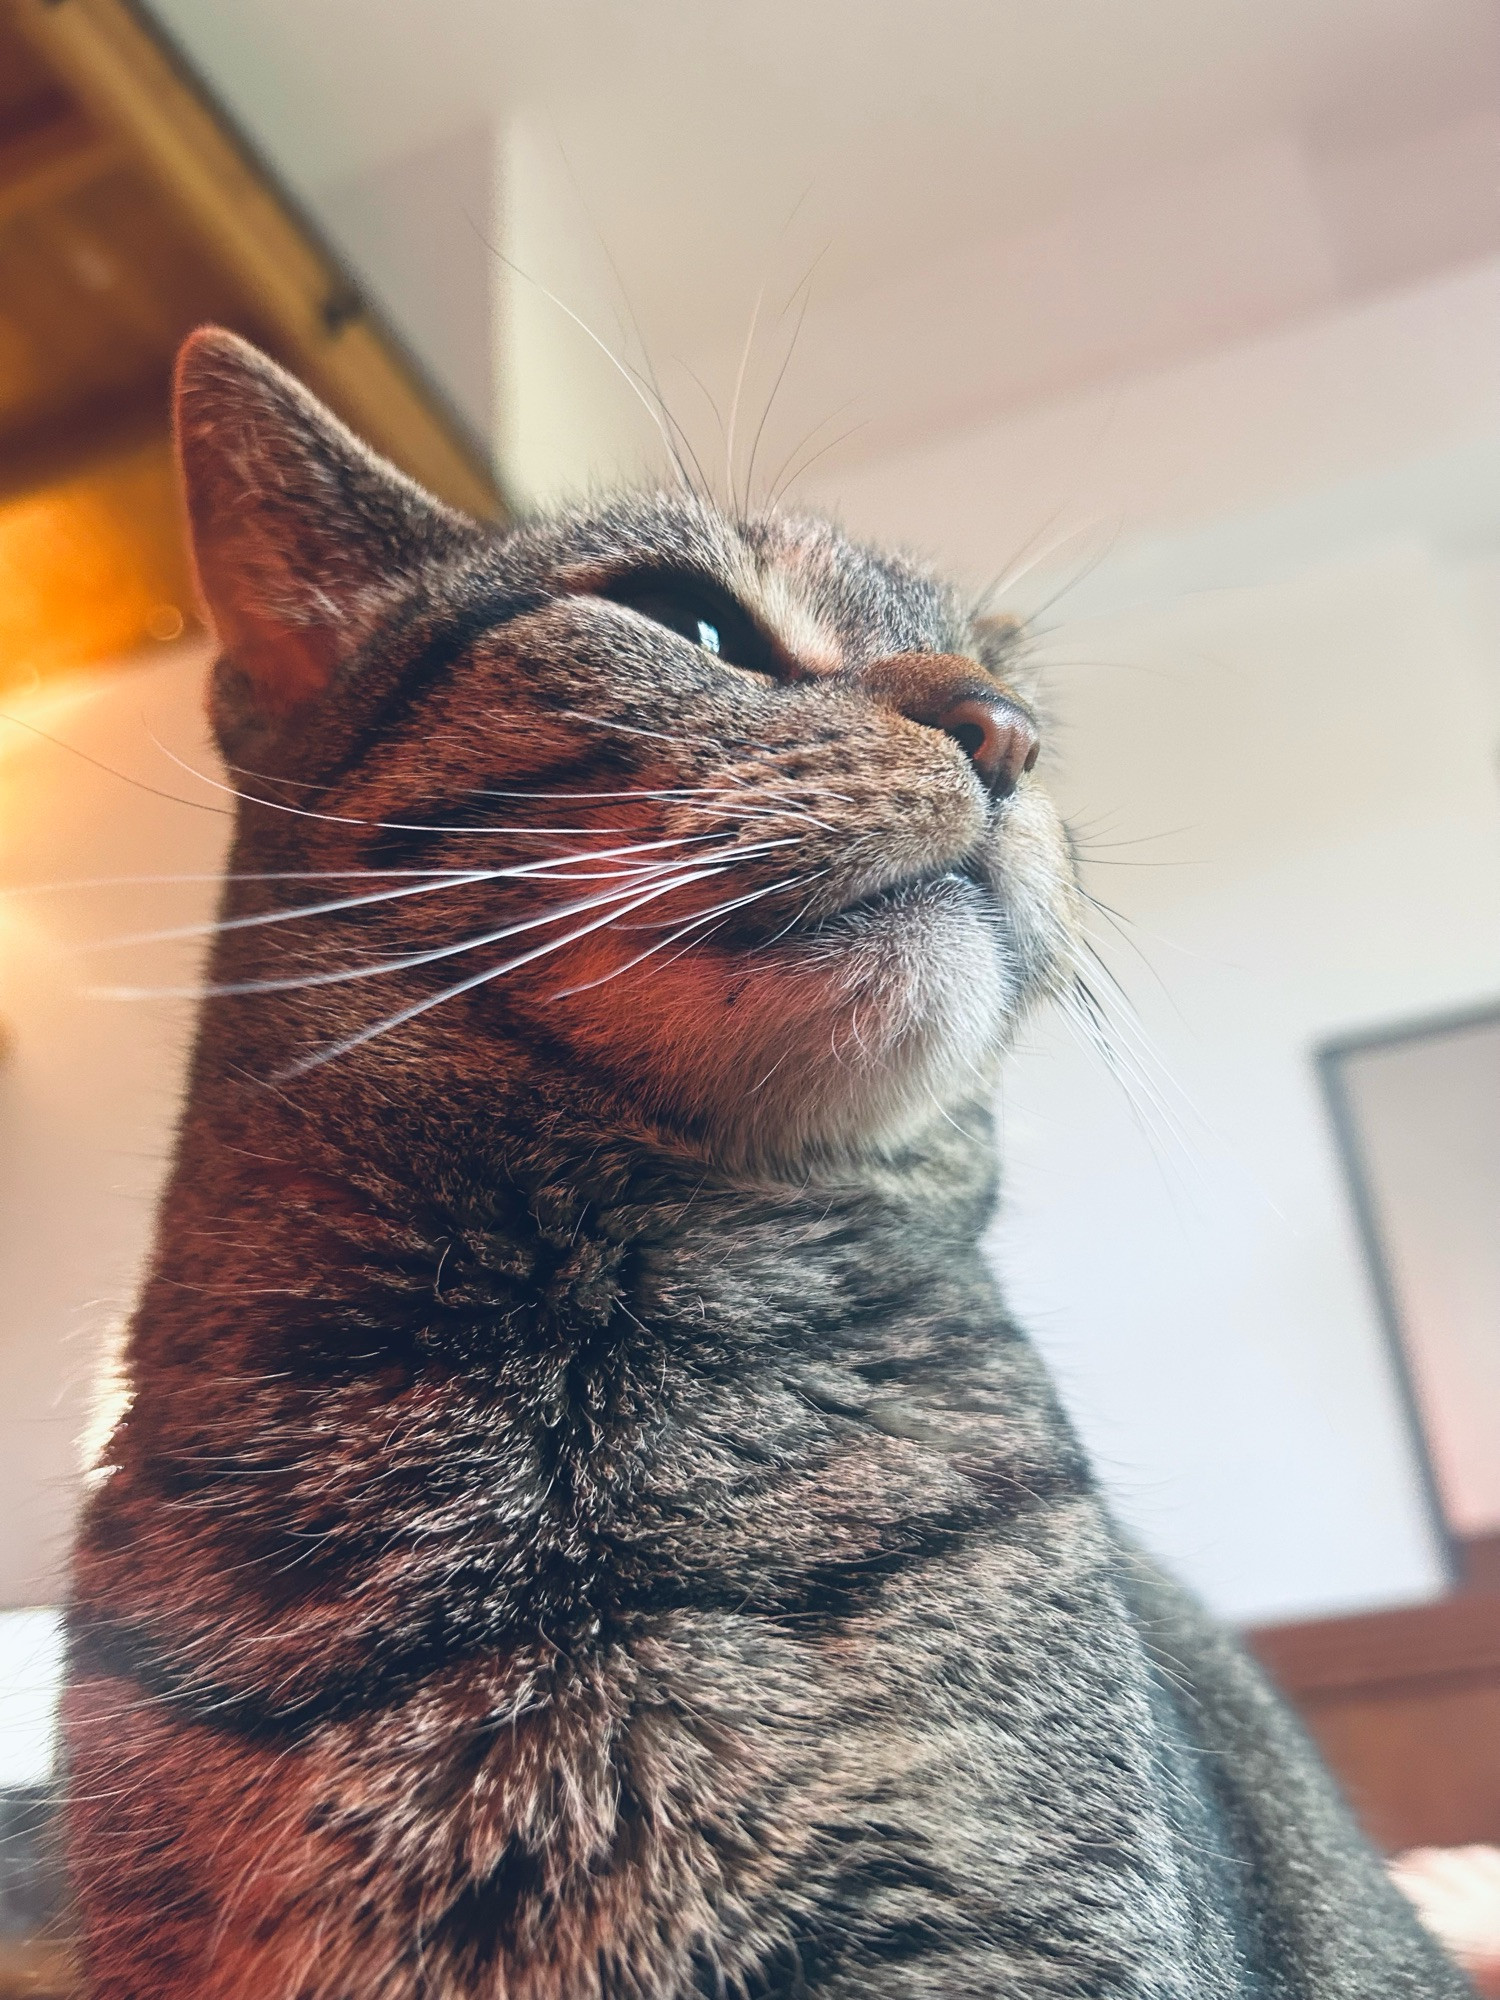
[174,326,480,744]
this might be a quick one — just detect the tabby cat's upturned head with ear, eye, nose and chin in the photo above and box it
[178,330,1076,1168]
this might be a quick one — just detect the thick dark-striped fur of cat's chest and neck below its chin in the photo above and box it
[64,1160,1222,1996]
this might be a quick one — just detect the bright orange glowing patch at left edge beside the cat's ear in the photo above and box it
[0,438,196,688]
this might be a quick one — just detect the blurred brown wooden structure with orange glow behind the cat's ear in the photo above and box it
[0,0,508,686]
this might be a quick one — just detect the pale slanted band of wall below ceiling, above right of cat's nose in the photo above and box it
[798,258,1500,592]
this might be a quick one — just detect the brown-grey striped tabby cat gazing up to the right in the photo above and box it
[64,330,1468,2000]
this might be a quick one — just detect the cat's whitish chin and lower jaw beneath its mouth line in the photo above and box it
[552,794,1076,1172]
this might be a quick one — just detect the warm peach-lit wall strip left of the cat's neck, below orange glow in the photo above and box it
[0,644,228,1608]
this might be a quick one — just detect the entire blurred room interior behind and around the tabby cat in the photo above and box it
[0,0,1500,1968]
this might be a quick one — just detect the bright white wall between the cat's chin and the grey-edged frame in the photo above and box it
[998,544,1500,1618]
